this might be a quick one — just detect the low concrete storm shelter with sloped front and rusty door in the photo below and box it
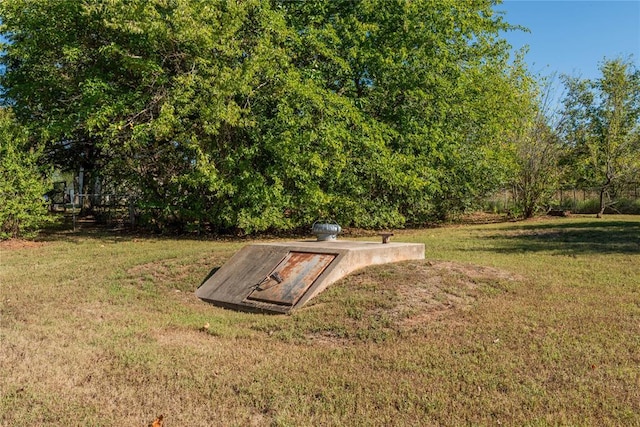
[196,239,425,313]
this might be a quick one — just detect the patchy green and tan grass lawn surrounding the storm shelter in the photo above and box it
[0,216,640,427]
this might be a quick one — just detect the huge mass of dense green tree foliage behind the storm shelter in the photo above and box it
[0,0,531,233]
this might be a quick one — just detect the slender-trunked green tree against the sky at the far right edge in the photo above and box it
[563,58,640,217]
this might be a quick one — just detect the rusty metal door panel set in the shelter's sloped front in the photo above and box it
[247,252,336,306]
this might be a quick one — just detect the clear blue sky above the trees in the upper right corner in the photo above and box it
[495,0,640,79]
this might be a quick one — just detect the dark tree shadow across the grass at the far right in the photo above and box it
[490,219,640,255]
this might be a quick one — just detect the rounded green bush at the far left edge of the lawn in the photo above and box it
[0,108,48,240]
